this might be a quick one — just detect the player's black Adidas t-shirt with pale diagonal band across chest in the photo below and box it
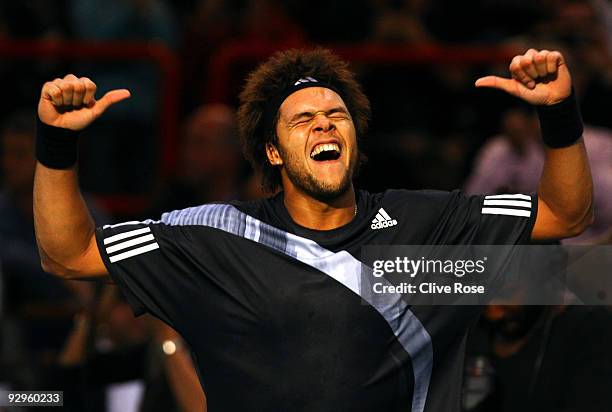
[97,190,537,412]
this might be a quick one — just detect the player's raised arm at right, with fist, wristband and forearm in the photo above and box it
[476,49,593,240]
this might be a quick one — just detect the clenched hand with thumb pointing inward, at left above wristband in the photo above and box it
[38,74,130,131]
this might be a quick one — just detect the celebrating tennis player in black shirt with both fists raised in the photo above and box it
[34,49,592,412]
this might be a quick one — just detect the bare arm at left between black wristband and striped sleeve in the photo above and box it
[34,163,104,277]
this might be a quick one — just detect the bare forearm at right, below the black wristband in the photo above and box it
[538,138,593,236]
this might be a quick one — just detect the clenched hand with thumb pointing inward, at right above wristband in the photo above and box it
[475,49,572,106]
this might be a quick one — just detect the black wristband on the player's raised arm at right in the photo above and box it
[537,89,583,149]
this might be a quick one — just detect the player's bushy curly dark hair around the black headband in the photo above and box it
[238,48,371,192]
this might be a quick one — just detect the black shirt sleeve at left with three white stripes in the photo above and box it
[96,221,191,325]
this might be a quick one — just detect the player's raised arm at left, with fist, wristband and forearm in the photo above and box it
[34,74,130,279]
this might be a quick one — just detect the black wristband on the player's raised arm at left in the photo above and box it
[36,119,79,169]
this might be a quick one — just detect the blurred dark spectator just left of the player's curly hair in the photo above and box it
[151,104,243,216]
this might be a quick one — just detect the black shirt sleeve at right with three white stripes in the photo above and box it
[438,191,538,245]
